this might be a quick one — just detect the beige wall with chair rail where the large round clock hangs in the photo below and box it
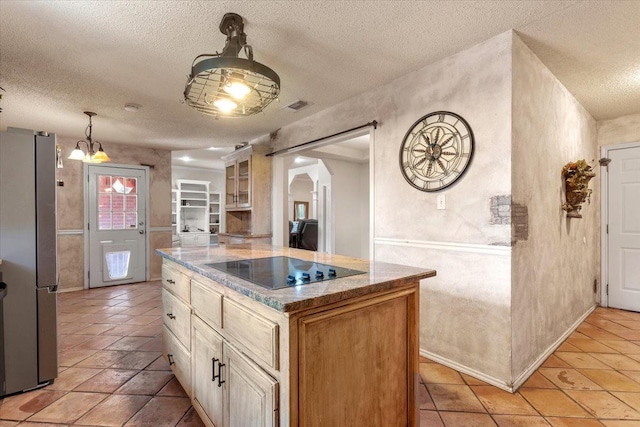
[264,32,511,384]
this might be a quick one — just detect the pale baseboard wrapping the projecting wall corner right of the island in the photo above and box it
[420,304,597,393]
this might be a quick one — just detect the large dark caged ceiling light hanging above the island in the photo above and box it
[184,13,280,118]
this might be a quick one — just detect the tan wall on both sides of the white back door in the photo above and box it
[56,137,171,291]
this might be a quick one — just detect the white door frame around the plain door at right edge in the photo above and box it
[600,141,640,307]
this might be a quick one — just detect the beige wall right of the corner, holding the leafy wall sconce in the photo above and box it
[511,36,600,379]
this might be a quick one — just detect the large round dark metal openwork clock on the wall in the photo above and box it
[400,111,473,191]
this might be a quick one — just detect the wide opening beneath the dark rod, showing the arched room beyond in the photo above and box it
[274,129,374,259]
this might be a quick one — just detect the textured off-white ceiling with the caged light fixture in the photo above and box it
[0,0,640,155]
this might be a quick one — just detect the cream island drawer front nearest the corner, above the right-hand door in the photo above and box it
[222,298,279,369]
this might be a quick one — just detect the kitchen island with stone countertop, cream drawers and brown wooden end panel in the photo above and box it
[157,244,435,427]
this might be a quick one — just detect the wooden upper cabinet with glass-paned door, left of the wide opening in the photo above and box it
[219,145,271,244]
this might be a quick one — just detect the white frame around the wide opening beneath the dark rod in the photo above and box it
[271,126,376,260]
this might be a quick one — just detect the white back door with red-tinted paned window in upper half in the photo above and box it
[87,165,147,288]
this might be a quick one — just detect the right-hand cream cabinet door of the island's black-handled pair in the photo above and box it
[223,342,279,427]
